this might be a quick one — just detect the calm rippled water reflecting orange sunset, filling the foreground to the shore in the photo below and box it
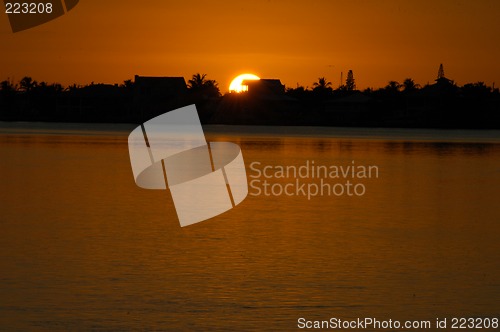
[0,123,500,331]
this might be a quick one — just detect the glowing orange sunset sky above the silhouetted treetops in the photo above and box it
[0,0,500,92]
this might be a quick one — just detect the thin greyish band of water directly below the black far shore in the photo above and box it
[0,121,500,144]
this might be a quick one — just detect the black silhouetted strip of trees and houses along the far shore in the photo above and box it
[0,65,500,129]
